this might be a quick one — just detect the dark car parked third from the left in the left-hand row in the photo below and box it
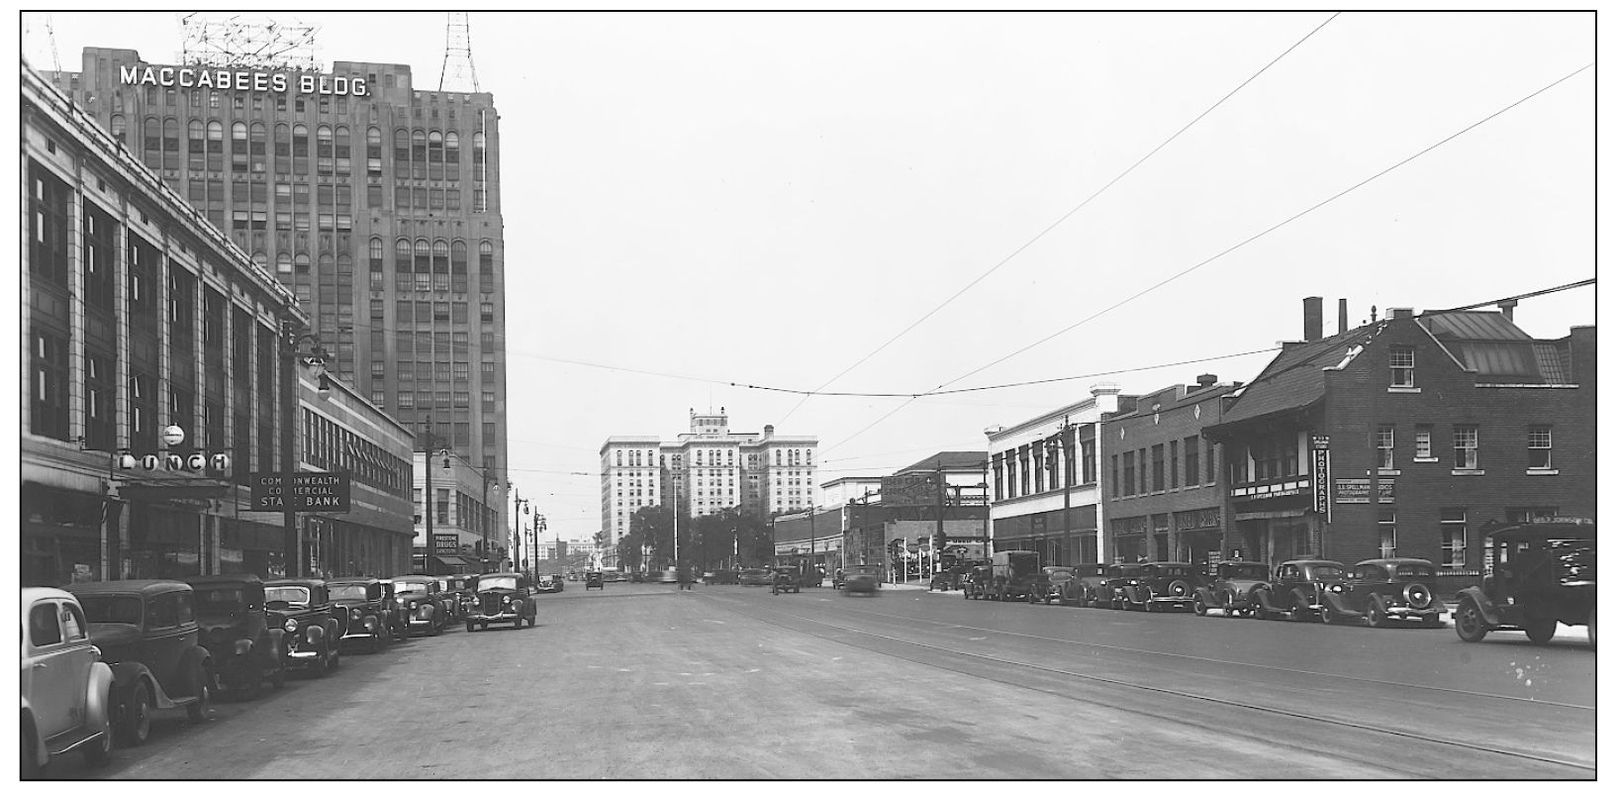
[186,574,287,700]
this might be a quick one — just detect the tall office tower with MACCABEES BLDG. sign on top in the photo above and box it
[47,47,508,476]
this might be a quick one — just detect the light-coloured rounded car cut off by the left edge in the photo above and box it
[18,587,113,768]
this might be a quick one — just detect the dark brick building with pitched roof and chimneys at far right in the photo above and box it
[1205,298,1596,585]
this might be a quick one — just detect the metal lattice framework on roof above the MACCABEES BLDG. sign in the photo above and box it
[180,13,321,71]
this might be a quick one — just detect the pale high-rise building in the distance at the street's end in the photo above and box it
[601,407,819,557]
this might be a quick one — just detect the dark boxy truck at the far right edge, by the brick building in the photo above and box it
[1454,520,1596,647]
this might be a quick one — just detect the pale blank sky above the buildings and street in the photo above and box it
[23,11,1596,538]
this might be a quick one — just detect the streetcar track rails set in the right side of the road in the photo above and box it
[709,600,1596,773]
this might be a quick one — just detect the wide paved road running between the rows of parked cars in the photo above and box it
[52,583,1596,780]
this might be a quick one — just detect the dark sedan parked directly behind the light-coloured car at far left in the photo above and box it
[71,579,214,745]
